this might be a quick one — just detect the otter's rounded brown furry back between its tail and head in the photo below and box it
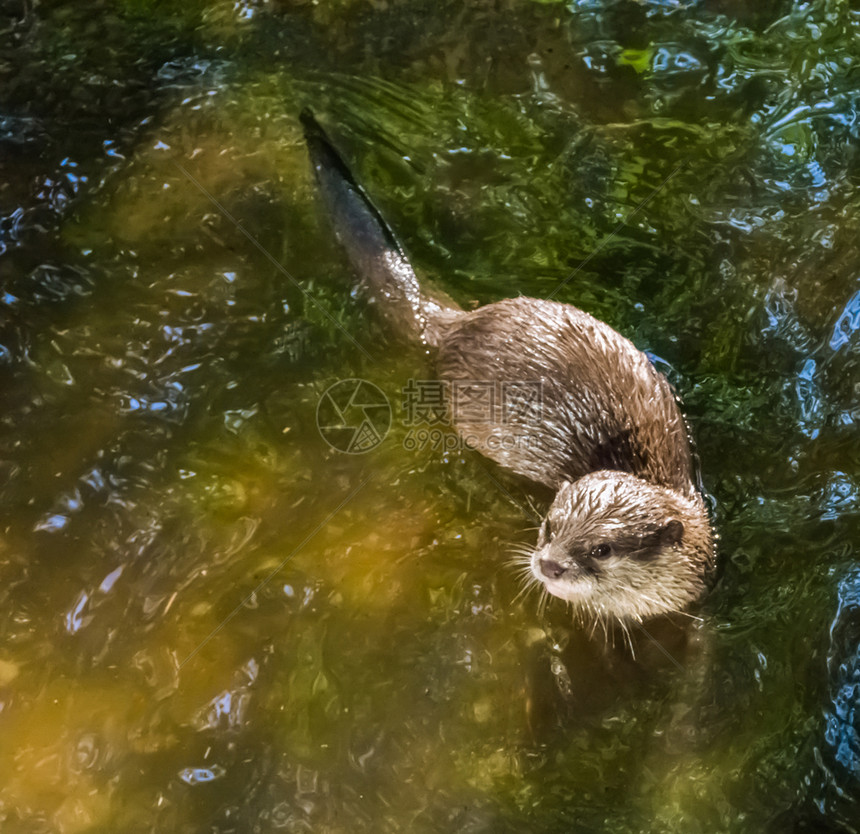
[437,298,692,493]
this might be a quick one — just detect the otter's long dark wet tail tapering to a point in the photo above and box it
[299,108,461,346]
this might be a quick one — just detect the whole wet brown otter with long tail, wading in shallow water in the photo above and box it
[300,109,714,625]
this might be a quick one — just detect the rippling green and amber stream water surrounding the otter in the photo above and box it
[0,0,860,834]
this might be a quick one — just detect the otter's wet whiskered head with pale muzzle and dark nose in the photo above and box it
[531,470,713,622]
